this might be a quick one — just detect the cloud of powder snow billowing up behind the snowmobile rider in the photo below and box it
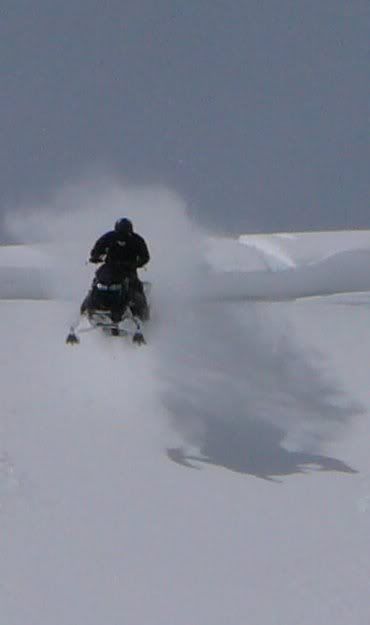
[2,178,199,302]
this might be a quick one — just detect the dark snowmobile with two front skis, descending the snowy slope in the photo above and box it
[66,263,151,345]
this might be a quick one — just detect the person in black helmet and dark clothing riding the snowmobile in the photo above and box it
[81,217,150,321]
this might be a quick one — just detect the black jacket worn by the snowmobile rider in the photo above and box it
[90,230,150,269]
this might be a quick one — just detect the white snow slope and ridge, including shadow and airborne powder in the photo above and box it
[0,186,370,625]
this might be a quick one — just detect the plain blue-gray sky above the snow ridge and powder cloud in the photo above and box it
[0,0,370,232]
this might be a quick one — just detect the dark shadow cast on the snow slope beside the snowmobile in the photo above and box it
[163,306,362,480]
